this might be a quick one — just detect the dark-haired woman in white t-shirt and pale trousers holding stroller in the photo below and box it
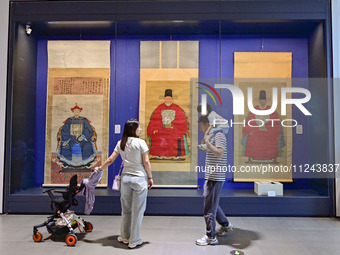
[95,119,153,248]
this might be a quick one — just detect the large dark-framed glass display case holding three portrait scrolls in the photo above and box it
[5,1,337,216]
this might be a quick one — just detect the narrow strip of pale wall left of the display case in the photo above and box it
[0,1,9,213]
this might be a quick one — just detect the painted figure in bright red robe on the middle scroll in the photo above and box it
[147,89,189,159]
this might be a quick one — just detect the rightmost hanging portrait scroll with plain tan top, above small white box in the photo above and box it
[234,52,292,182]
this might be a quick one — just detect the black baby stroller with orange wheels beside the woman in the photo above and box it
[33,175,93,246]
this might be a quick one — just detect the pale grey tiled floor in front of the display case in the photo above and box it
[0,215,340,255]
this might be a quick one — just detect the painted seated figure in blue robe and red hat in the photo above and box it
[57,104,97,168]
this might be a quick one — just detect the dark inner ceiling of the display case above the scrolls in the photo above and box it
[24,20,321,37]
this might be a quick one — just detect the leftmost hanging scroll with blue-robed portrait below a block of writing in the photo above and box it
[44,41,110,186]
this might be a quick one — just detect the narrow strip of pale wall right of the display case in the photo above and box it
[332,0,340,216]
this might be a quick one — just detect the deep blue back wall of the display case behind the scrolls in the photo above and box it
[33,35,310,189]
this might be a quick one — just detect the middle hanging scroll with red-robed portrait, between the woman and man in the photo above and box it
[139,41,198,186]
